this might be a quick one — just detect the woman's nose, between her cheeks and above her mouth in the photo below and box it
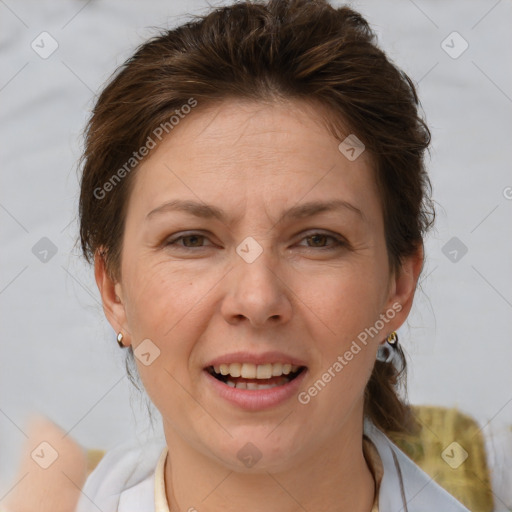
[221,243,293,328]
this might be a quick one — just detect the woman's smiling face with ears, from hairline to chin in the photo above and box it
[96,101,421,470]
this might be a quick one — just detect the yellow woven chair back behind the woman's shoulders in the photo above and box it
[87,405,494,512]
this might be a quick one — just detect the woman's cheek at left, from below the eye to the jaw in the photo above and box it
[120,262,228,431]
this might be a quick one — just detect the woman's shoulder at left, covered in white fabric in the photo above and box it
[75,438,165,512]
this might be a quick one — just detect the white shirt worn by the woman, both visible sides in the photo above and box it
[75,420,469,512]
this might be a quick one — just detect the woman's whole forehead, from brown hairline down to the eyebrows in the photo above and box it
[133,101,378,226]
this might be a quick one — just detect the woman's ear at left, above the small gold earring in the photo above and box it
[94,248,130,345]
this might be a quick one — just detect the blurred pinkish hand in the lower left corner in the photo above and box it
[0,416,87,512]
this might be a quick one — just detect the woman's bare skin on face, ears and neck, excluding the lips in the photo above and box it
[95,100,423,512]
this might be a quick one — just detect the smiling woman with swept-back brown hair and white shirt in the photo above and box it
[5,0,472,512]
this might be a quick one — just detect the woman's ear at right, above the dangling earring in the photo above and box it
[386,243,424,332]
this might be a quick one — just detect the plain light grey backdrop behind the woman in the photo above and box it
[0,0,512,504]
